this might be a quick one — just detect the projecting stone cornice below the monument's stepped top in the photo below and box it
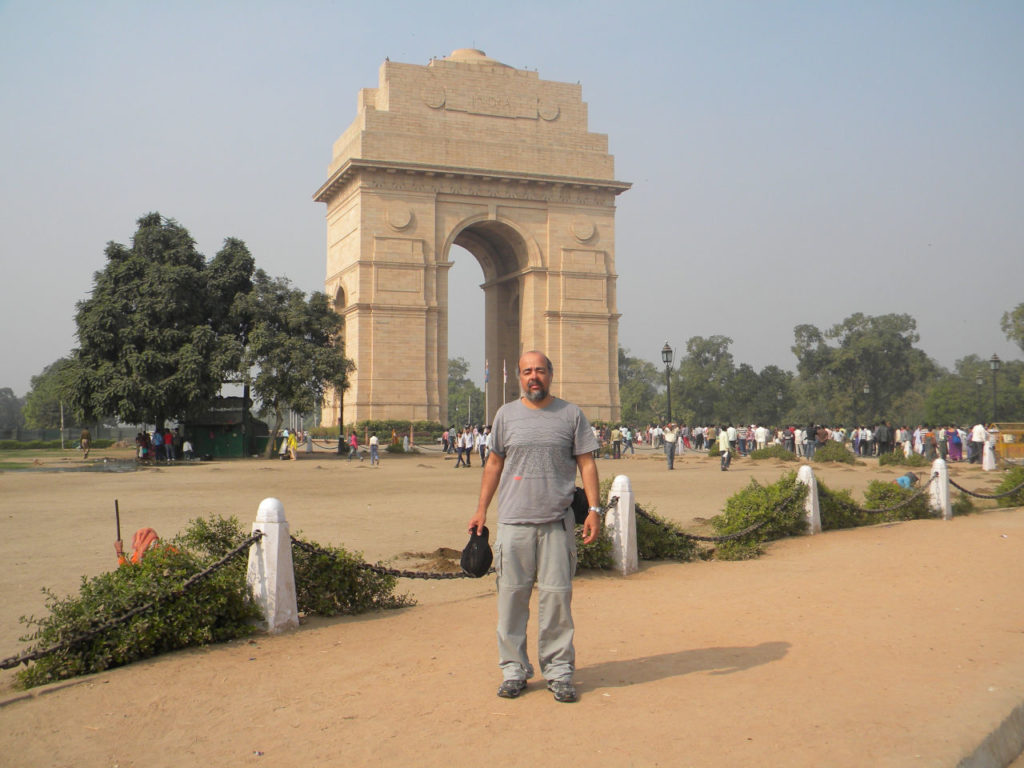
[313,158,633,203]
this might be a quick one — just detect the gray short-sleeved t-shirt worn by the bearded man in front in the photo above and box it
[492,397,599,524]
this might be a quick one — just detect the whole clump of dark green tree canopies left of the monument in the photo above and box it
[60,213,351,438]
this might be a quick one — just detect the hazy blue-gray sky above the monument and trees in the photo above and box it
[0,0,1024,395]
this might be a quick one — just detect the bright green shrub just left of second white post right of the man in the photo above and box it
[712,472,807,560]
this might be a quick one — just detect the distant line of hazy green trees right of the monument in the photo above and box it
[618,304,1024,426]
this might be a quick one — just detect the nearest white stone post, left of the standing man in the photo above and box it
[246,499,299,632]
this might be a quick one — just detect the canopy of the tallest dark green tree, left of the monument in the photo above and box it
[66,213,224,425]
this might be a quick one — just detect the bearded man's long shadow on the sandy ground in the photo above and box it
[577,642,790,688]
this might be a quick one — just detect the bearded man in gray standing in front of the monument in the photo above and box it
[469,351,601,701]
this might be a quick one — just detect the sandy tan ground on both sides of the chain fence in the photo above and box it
[0,444,1024,768]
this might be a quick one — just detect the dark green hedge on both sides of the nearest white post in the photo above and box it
[17,516,413,688]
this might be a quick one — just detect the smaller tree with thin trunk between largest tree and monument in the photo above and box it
[233,269,351,458]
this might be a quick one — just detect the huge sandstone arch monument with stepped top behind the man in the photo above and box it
[313,49,630,425]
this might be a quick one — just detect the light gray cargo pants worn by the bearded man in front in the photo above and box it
[495,510,577,680]
